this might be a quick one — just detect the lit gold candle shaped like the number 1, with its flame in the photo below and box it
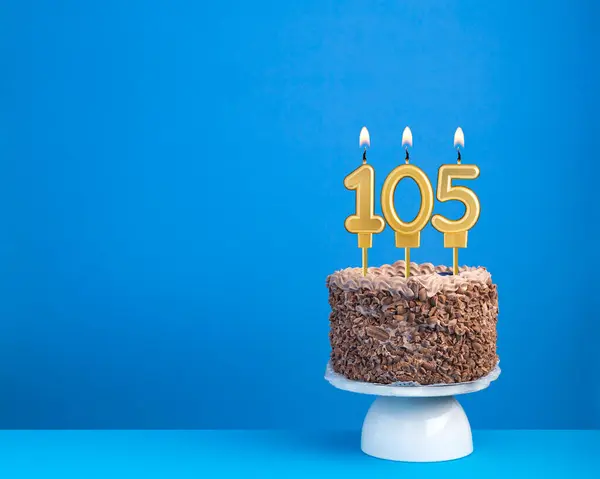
[344,126,385,276]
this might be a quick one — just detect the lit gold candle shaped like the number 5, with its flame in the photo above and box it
[431,127,481,274]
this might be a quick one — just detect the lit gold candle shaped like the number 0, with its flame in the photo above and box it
[381,127,433,278]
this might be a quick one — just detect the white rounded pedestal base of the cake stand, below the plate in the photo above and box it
[361,396,473,462]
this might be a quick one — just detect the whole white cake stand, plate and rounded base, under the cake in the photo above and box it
[325,363,500,462]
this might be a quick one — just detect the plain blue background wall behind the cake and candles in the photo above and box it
[0,0,600,428]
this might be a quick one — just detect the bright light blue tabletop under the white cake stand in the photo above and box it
[0,431,600,479]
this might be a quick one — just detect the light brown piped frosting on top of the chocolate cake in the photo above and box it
[327,260,492,298]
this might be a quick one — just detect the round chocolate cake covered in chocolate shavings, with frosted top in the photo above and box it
[327,261,498,385]
